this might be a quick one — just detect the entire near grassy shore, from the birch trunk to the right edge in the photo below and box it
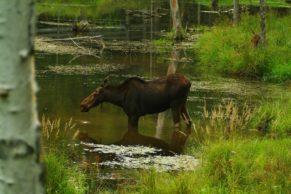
[42,99,291,194]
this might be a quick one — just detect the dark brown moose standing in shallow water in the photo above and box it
[80,74,192,134]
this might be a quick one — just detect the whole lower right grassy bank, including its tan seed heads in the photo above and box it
[100,100,291,194]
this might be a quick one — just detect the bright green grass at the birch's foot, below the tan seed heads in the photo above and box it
[43,152,87,194]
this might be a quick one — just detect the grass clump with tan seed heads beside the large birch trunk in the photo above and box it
[41,117,88,194]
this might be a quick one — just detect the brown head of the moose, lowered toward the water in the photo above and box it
[80,77,108,112]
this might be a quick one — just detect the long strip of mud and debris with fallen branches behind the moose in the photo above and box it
[35,34,198,57]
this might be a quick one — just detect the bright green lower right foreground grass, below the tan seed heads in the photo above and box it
[110,139,291,194]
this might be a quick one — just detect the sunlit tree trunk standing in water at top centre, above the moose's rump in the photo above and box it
[170,0,185,41]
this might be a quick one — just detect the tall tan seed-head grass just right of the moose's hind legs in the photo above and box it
[190,100,254,145]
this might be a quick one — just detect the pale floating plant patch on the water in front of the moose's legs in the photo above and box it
[81,142,199,171]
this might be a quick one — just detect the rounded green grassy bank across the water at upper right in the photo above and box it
[196,15,291,82]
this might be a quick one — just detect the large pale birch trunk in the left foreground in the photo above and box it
[0,0,43,194]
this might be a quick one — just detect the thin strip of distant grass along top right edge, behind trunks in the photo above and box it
[195,0,290,7]
